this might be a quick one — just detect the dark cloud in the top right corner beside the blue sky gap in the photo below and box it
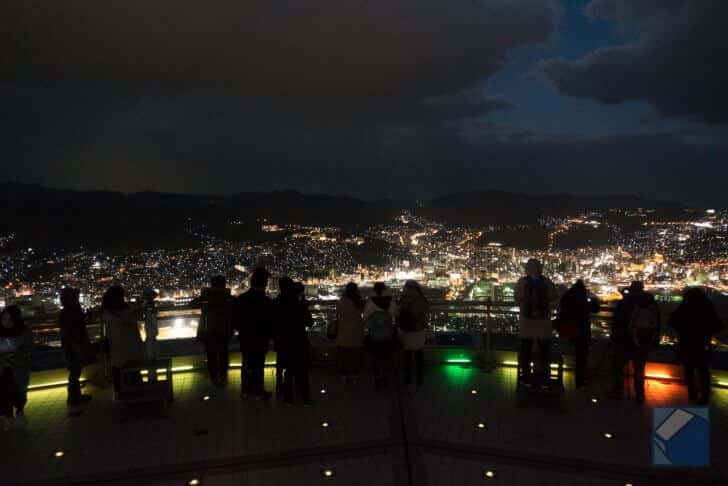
[539,0,728,124]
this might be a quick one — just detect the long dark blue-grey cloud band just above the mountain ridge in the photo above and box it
[0,84,728,205]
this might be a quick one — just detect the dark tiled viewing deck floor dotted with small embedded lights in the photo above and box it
[5,365,728,485]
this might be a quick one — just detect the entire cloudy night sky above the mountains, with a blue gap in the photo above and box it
[0,0,728,206]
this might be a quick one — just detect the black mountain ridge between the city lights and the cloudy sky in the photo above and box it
[0,183,681,249]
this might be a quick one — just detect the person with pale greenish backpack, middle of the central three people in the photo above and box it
[364,282,397,391]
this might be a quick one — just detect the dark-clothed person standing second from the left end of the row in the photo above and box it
[58,287,92,406]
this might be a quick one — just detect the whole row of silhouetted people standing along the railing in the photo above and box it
[0,259,724,430]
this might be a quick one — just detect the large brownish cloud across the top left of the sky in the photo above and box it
[0,0,560,101]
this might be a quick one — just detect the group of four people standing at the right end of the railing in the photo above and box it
[515,259,725,405]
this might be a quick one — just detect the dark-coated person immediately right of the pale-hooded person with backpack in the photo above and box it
[557,280,599,390]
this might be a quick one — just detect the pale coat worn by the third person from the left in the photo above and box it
[103,306,144,368]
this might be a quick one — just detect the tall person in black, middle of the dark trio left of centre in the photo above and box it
[234,267,275,399]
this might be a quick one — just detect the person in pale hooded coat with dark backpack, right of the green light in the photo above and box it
[515,258,559,386]
